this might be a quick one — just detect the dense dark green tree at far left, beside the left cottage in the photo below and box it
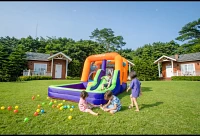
[0,44,27,81]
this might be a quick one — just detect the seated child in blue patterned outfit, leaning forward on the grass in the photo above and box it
[100,91,121,114]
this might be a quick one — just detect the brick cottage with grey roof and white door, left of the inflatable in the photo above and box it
[23,52,72,79]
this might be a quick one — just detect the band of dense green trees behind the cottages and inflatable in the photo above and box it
[0,18,200,82]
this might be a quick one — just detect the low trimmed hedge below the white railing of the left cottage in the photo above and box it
[18,76,52,81]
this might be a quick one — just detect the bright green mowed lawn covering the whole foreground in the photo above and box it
[0,80,200,134]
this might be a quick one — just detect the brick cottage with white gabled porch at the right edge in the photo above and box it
[154,52,200,79]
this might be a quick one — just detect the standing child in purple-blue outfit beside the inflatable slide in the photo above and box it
[126,71,142,111]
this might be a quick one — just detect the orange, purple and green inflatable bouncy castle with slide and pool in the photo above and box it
[48,52,128,105]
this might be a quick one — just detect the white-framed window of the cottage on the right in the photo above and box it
[181,64,195,76]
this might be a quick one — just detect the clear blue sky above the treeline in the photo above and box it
[0,1,200,50]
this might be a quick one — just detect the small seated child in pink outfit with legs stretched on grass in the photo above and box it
[78,91,98,116]
